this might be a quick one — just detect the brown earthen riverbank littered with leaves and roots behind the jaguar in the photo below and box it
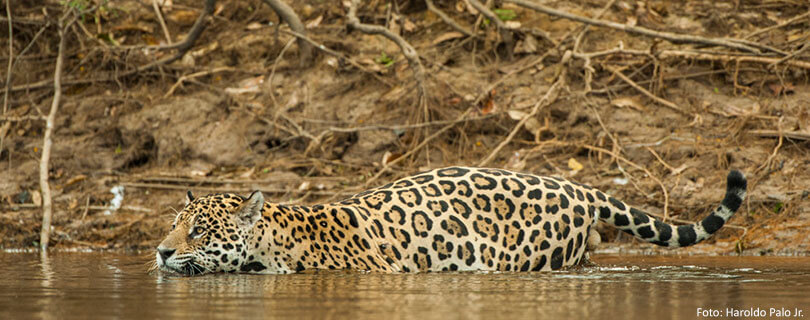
[0,0,810,255]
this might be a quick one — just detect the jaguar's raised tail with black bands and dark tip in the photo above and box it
[599,170,748,247]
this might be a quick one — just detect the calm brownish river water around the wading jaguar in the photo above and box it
[0,252,810,320]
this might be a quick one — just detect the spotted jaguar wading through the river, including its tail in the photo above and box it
[155,167,747,276]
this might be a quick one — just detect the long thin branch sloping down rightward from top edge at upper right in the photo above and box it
[505,0,787,56]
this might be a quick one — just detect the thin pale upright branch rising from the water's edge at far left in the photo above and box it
[39,9,78,251]
